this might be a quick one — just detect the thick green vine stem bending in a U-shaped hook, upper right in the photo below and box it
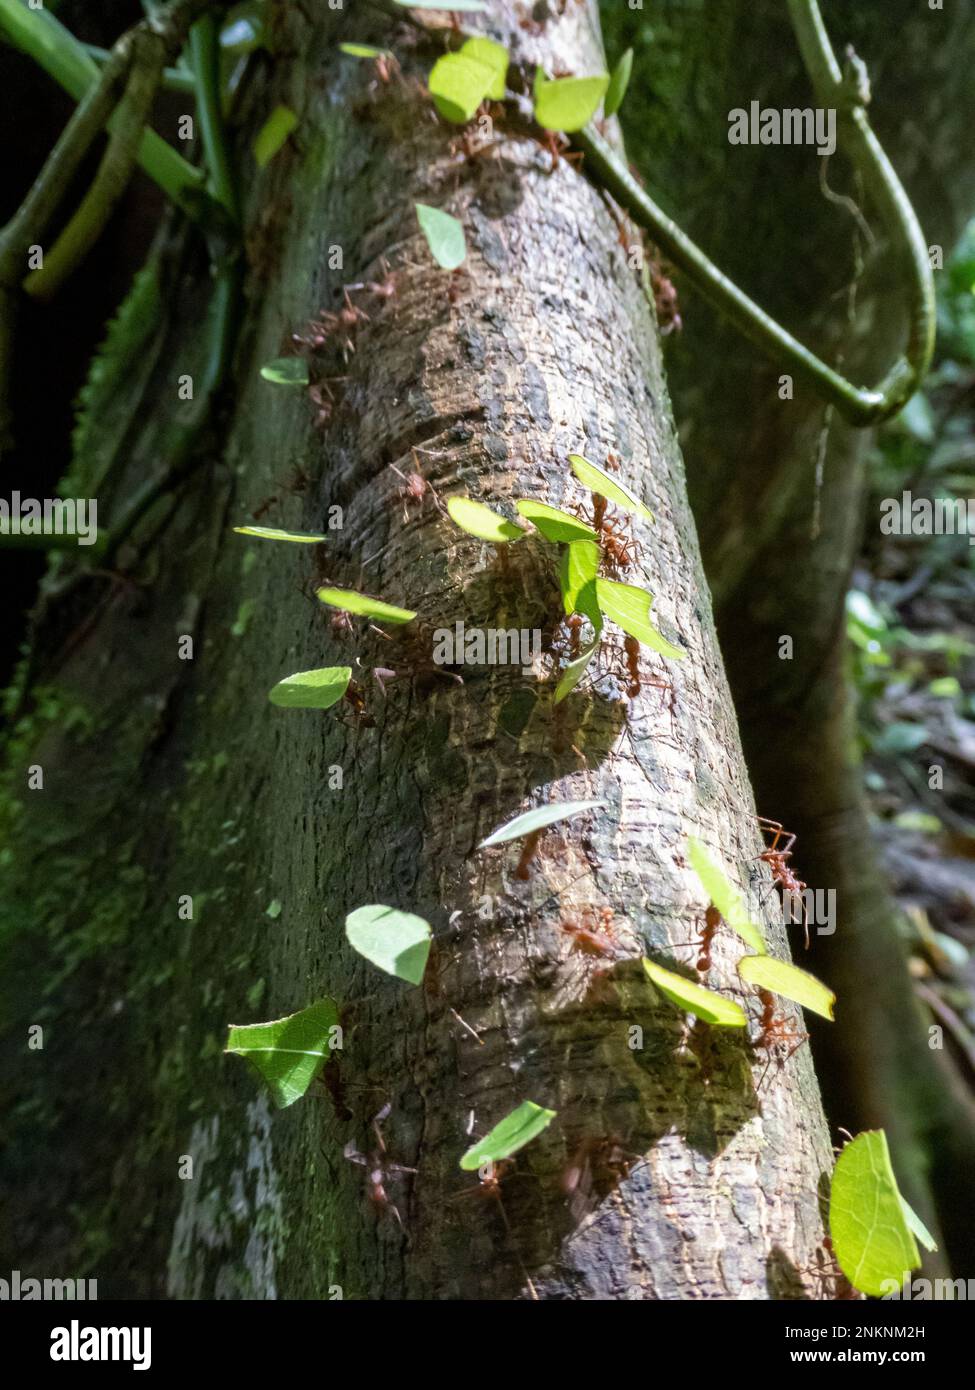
[573,0,935,427]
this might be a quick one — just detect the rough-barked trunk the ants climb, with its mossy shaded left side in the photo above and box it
[7,6,830,1298]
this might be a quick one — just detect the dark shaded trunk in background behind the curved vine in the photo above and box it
[609,0,975,1270]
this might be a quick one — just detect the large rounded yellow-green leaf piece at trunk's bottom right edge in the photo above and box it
[829,1130,921,1298]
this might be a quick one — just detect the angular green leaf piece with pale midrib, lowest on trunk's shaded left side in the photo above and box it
[225,999,338,1109]
